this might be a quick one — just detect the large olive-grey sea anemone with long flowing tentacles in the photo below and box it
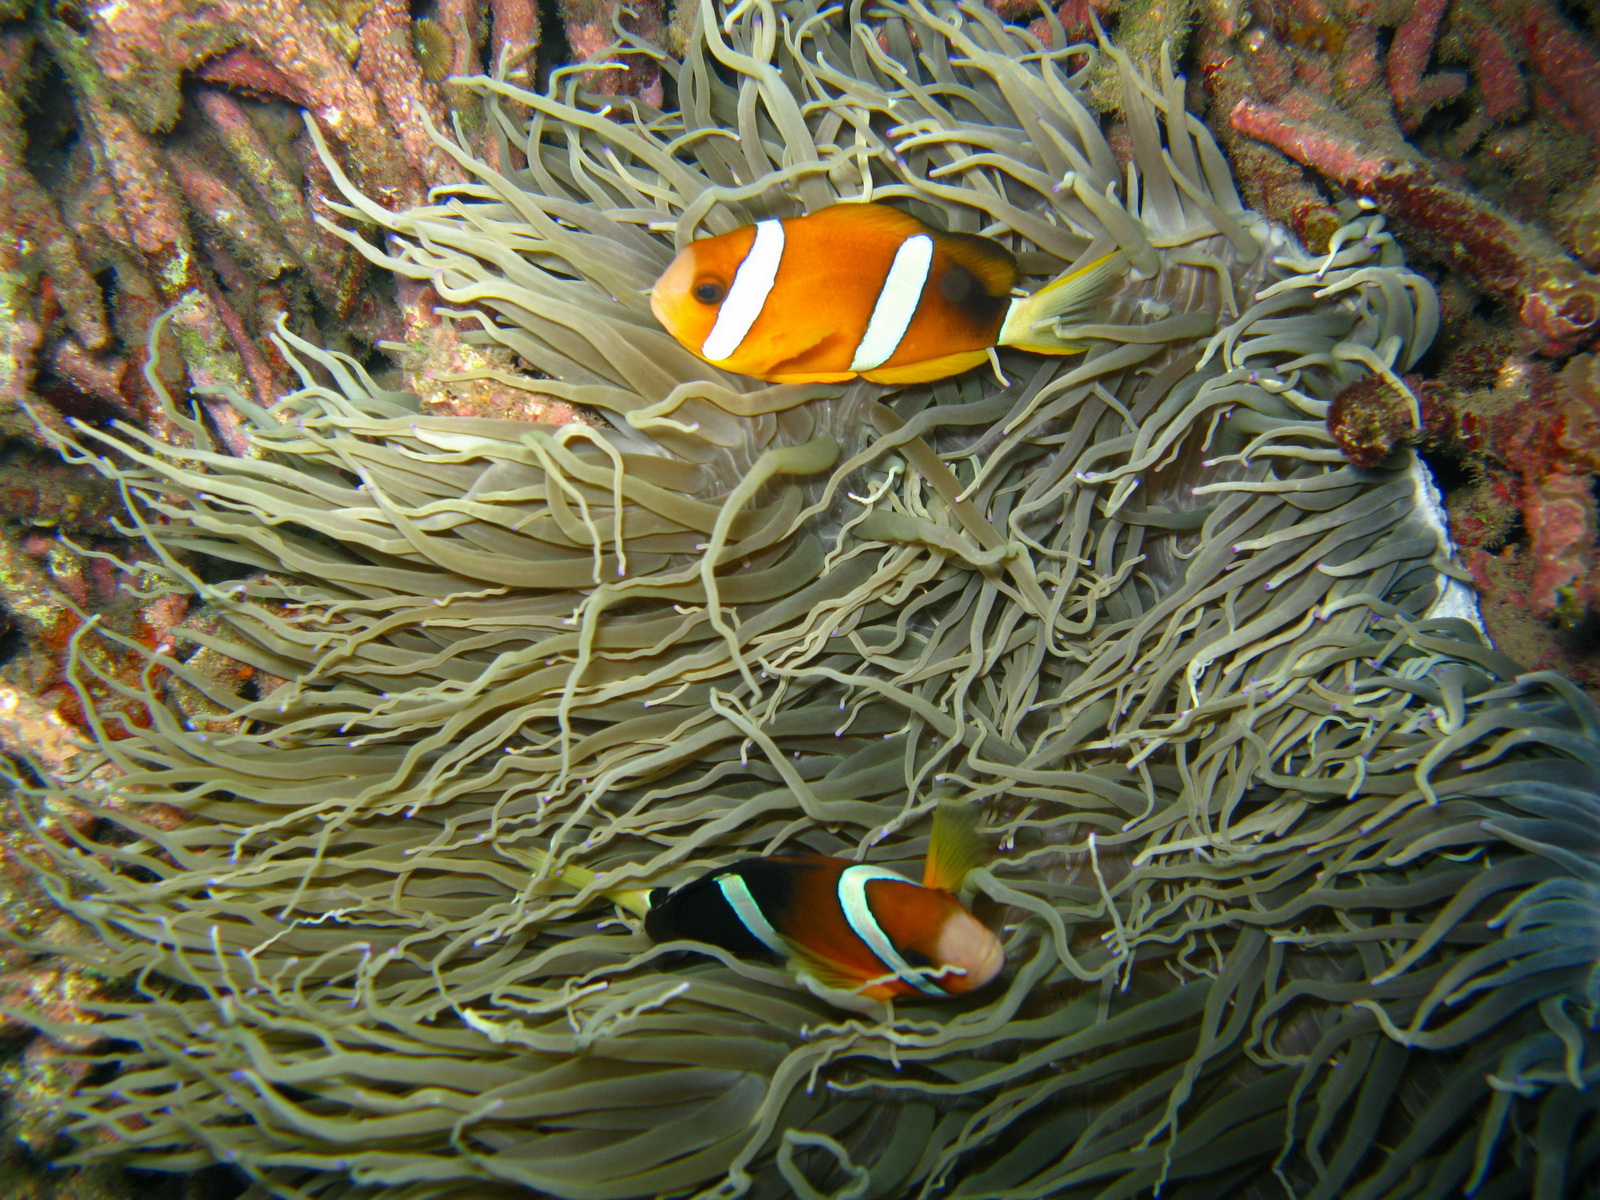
[12,0,1600,1200]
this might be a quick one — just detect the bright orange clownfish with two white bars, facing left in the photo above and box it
[650,203,1125,384]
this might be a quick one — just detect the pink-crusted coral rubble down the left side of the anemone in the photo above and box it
[0,0,666,1200]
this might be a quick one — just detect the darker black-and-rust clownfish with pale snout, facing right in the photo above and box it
[645,808,1005,1002]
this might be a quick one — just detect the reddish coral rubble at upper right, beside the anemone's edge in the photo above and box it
[1195,0,1600,683]
